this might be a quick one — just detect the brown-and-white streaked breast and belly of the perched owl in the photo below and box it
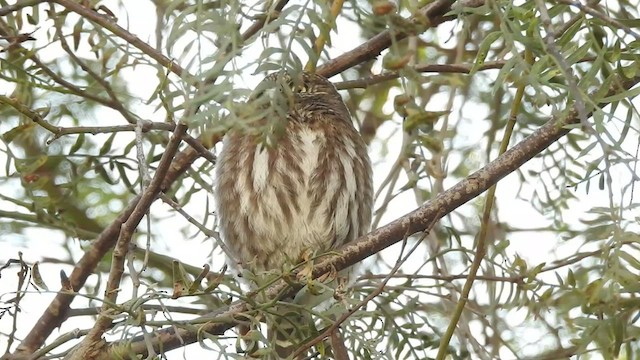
[216,121,372,271]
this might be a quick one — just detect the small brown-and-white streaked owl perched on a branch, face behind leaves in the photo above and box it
[216,72,373,358]
